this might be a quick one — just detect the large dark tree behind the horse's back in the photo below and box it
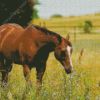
[0,0,38,26]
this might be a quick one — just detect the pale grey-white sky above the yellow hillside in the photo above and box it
[35,0,100,18]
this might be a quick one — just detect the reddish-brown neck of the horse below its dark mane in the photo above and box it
[26,27,61,51]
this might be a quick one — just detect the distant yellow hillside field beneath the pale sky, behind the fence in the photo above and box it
[31,14,100,32]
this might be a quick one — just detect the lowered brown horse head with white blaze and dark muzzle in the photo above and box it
[54,34,73,74]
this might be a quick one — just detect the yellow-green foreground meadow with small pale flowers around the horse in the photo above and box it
[0,33,100,100]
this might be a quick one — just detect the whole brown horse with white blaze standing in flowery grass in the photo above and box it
[0,24,73,87]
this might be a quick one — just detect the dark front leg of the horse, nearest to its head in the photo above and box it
[36,63,46,95]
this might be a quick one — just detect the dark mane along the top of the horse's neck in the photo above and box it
[28,24,62,44]
